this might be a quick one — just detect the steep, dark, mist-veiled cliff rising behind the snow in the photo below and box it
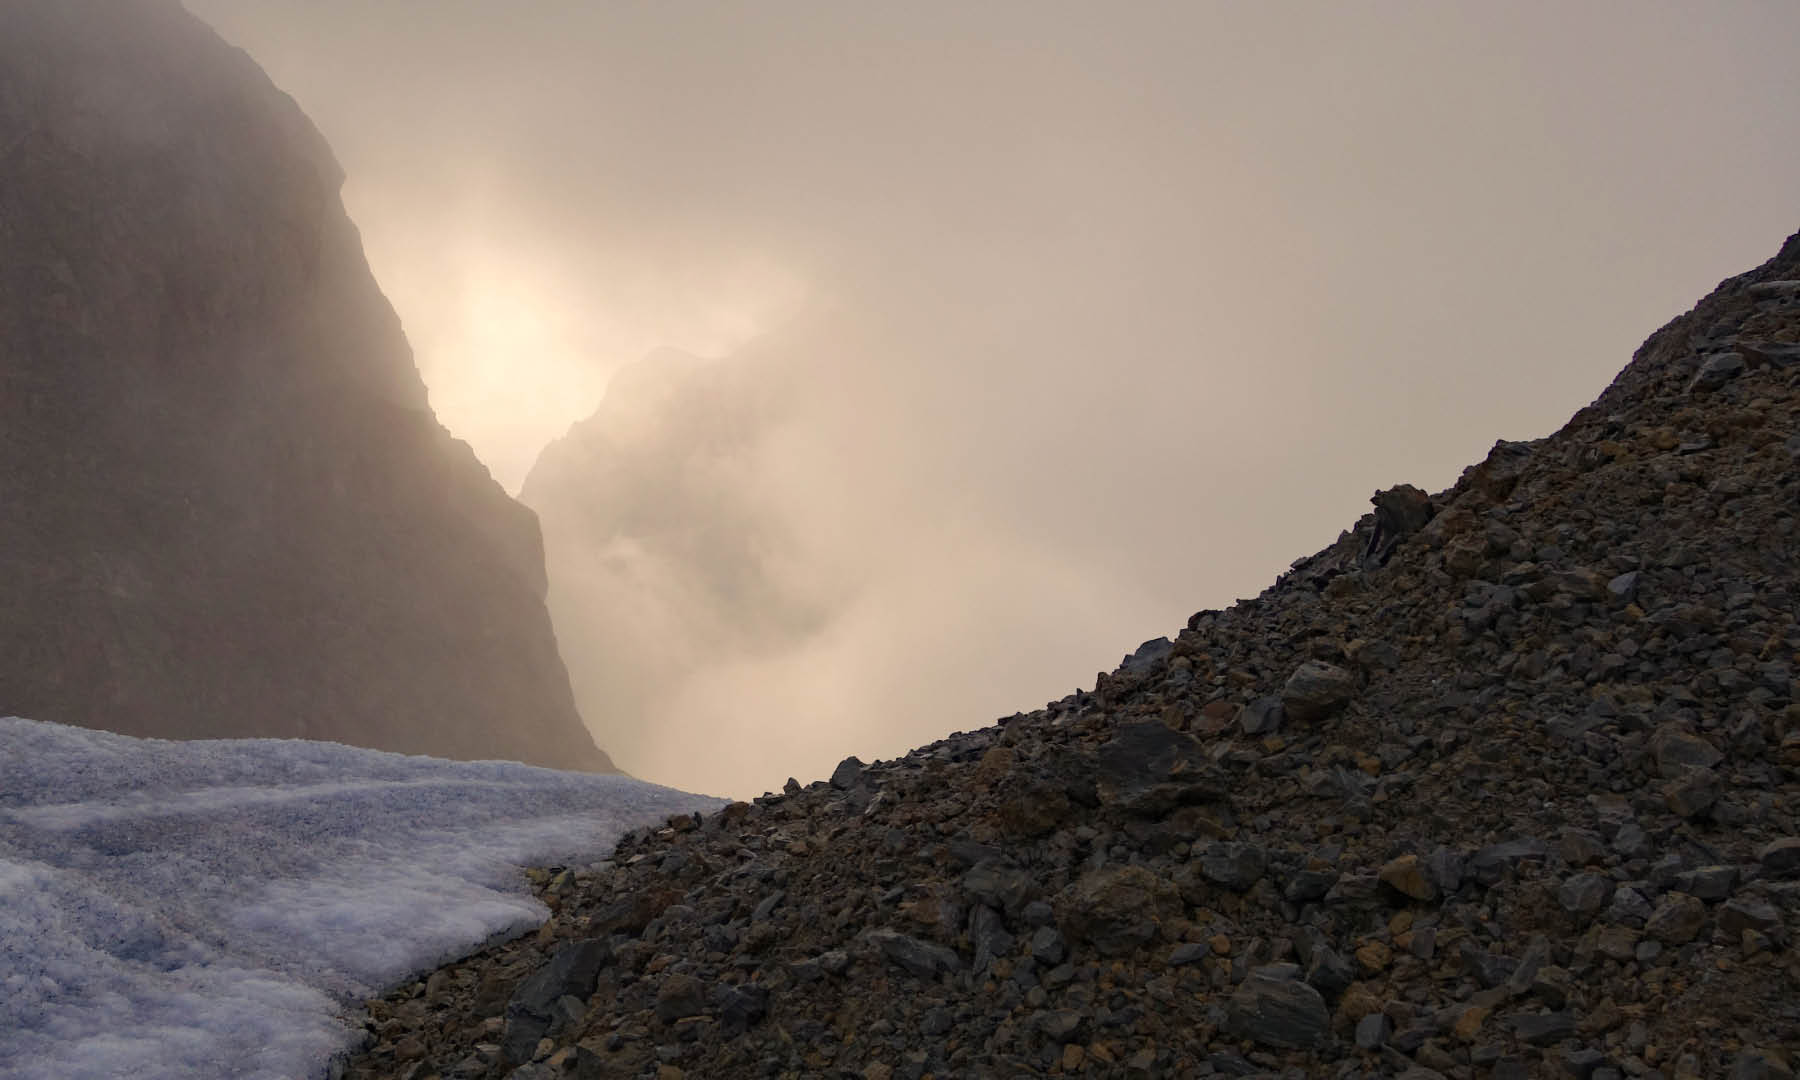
[0,0,610,770]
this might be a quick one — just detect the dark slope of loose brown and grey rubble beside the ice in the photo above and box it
[349,236,1800,1080]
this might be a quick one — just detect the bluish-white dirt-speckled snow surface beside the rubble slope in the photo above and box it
[0,718,720,1080]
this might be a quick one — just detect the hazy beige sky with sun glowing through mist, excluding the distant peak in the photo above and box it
[187,0,1800,794]
